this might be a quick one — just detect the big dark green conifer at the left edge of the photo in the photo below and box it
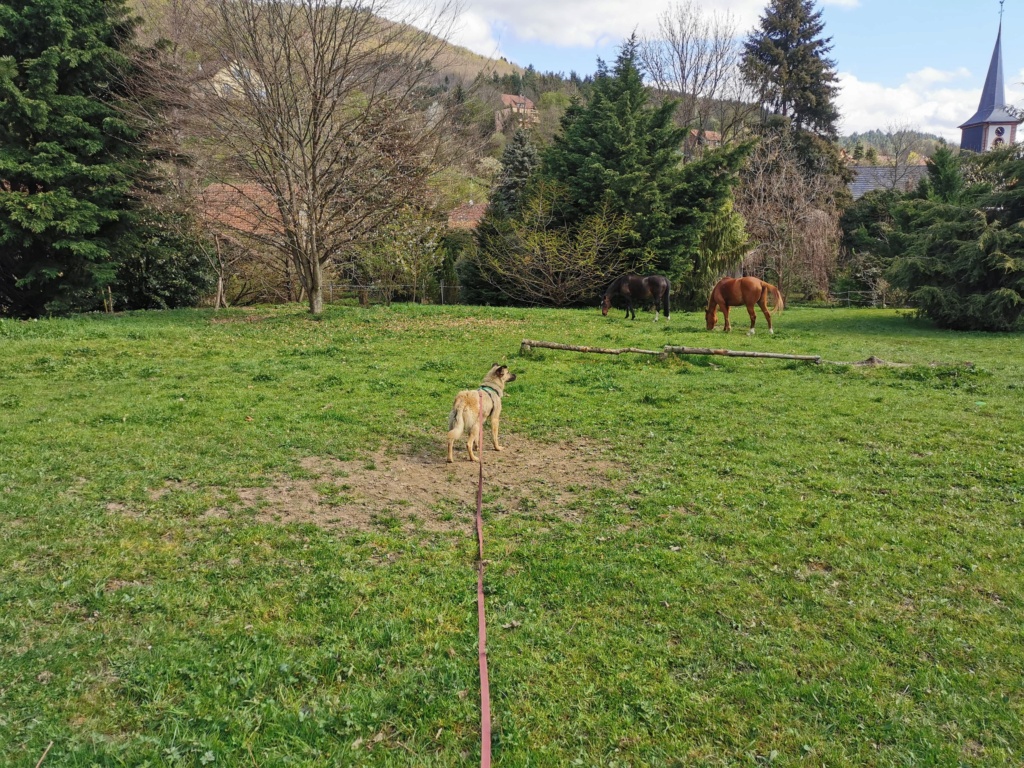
[0,0,174,316]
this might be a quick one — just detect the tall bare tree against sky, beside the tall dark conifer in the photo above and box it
[640,0,757,148]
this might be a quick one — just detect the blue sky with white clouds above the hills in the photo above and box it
[452,0,1024,143]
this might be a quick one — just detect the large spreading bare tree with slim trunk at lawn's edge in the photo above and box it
[143,0,458,314]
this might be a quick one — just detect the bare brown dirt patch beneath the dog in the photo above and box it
[228,435,625,536]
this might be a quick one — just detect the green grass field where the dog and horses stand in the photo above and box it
[0,306,1024,768]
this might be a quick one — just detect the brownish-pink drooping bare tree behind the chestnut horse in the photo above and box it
[736,133,843,293]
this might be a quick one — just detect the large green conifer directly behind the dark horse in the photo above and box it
[540,37,750,292]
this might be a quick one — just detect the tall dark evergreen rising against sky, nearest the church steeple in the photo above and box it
[741,0,839,138]
